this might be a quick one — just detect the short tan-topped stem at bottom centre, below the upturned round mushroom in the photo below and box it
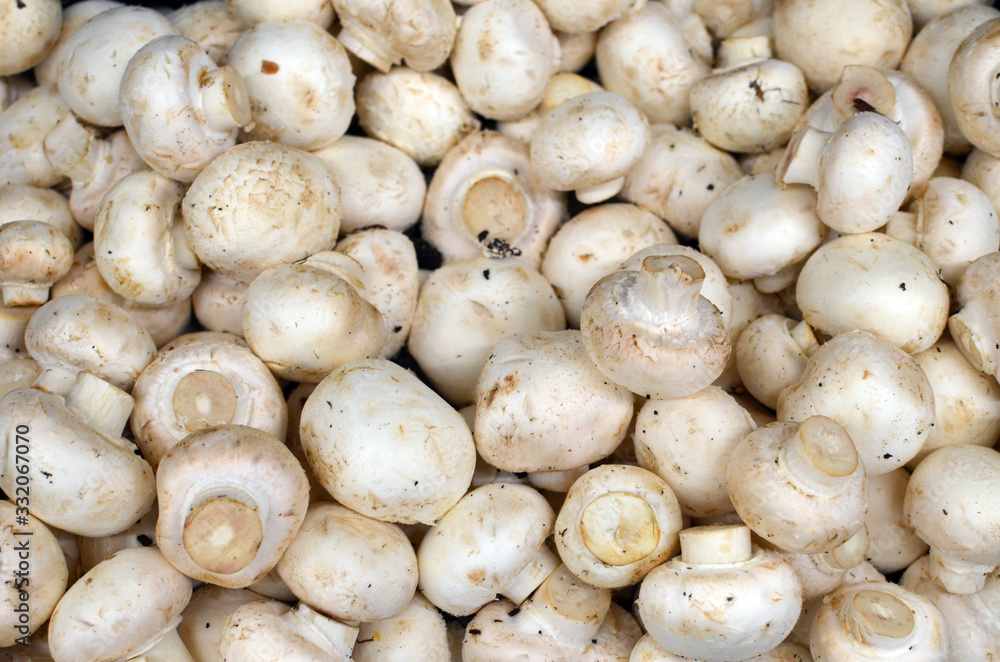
[523,566,611,648]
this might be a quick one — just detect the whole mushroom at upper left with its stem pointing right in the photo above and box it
[120,35,251,182]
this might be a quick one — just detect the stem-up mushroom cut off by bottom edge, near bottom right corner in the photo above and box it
[809,581,952,662]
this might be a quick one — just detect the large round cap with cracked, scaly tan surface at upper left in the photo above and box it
[183,142,340,284]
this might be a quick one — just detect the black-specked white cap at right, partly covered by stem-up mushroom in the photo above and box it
[778,331,934,476]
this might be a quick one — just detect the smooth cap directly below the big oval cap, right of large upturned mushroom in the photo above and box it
[277,503,417,621]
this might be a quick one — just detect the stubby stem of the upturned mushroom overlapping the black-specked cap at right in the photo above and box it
[778,416,858,494]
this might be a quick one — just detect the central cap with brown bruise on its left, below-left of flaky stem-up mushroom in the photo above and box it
[474,330,632,472]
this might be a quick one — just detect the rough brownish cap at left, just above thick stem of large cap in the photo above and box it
[24,295,156,391]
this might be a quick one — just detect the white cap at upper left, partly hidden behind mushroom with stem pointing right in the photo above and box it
[58,7,177,127]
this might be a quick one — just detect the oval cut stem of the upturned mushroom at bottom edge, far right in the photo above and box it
[839,590,915,650]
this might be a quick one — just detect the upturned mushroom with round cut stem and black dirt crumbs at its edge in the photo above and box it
[420,131,566,269]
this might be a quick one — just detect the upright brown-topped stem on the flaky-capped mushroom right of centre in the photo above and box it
[622,255,705,328]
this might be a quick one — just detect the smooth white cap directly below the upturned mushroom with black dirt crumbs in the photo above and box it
[407,257,566,406]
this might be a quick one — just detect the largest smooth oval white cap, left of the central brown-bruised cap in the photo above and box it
[300,359,476,524]
